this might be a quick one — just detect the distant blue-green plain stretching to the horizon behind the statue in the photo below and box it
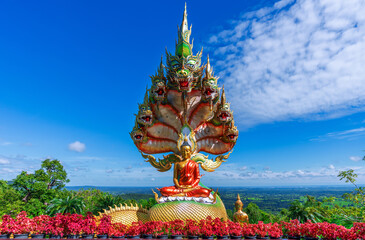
[66,186,354,214]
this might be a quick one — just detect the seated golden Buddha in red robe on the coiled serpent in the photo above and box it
[159,142,212,197]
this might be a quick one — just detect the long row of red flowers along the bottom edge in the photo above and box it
[0,212,365,240]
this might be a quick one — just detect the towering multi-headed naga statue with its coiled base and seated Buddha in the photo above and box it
[97,5,238,223]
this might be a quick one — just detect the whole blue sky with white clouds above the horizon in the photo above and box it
[0,0,365,186]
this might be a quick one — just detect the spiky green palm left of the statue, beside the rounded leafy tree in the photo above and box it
[47,196,85,216]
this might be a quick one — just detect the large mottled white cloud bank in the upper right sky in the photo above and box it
[210,0,365,126]
